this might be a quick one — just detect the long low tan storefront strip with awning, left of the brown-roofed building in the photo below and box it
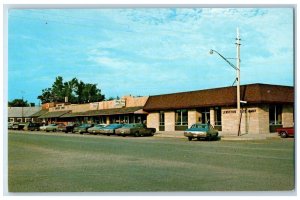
[38,96,148,124]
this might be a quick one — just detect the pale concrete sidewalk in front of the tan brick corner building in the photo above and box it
[154,131,280,141]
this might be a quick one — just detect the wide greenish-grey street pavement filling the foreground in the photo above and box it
[8,132,295,192]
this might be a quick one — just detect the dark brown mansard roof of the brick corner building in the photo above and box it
[144,83,294,111]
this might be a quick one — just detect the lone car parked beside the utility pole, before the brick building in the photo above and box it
[184,123,219,141]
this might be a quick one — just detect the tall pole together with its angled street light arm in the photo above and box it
[209,28,241,136]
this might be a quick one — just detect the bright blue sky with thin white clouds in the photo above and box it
[7,7,294,105]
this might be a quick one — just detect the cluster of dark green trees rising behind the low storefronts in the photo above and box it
[38,76,105,103]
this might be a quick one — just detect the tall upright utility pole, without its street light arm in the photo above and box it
[236,28,242,136]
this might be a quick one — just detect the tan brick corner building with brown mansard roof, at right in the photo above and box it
[144,84,294,135]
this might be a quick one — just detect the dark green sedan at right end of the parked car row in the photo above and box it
[115,123,156,137]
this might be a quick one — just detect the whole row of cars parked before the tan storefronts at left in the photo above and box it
[8,123,156,136]
